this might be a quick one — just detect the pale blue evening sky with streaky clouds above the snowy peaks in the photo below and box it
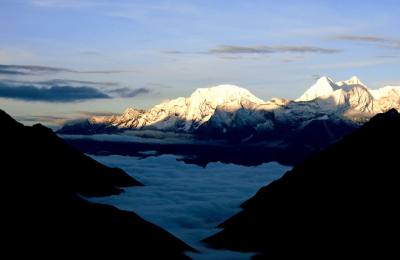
[0,0,400,124]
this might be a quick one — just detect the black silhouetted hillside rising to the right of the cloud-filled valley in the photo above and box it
[204,110,400,259]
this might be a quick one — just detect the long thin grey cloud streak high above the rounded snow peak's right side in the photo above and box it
[208,45,341,54]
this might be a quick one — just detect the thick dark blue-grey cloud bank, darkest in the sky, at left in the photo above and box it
[0,83,111,102]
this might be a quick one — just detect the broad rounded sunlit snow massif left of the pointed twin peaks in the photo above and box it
[91,85,265,132]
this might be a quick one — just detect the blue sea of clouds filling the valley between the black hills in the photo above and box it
[90,155,290,259]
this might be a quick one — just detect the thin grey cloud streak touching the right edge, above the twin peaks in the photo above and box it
[332,35,400,49]
